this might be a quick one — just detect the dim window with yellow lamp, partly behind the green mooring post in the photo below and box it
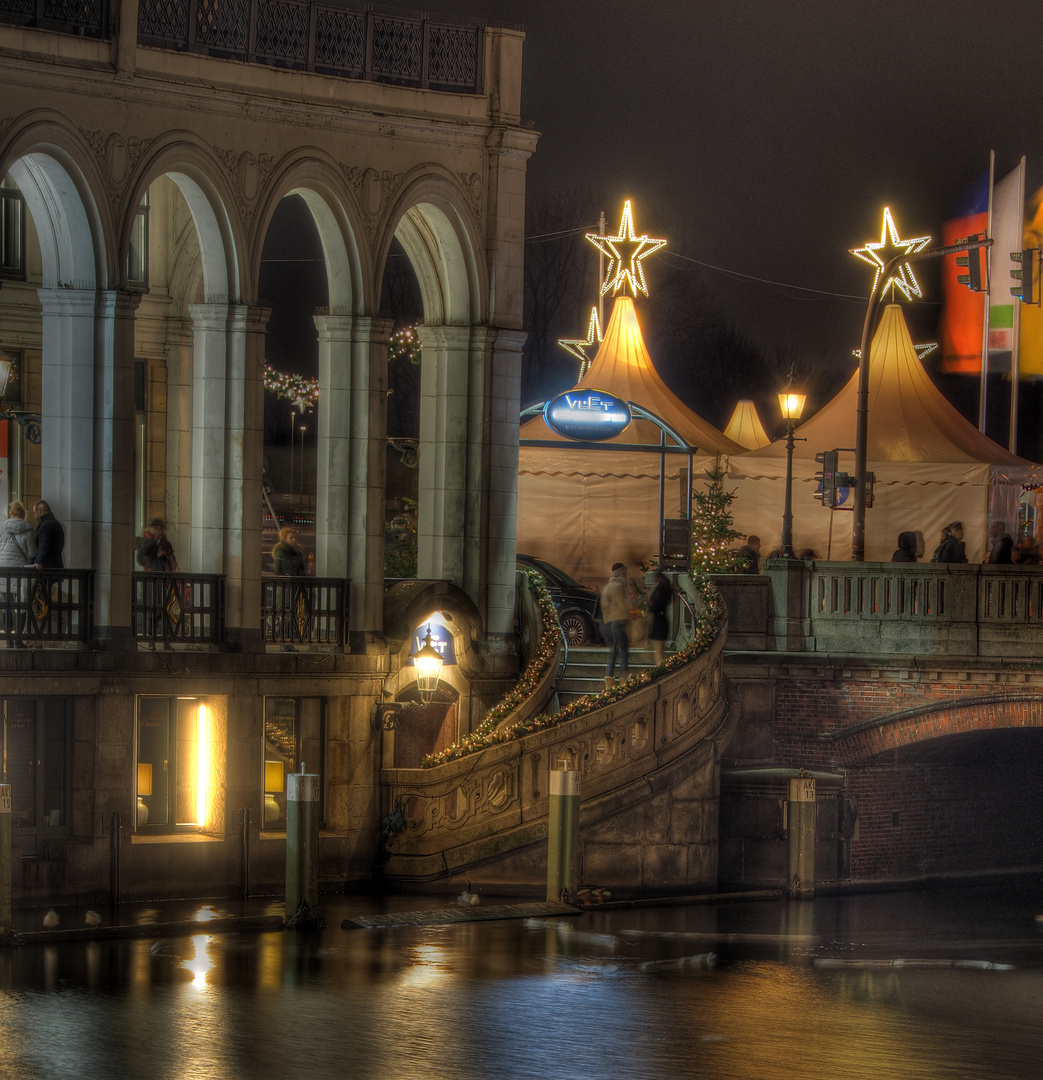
[261,698,326,829]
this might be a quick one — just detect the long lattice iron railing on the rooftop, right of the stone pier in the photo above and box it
[133,0,484,94]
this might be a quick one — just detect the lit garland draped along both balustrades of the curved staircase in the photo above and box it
[420,564,724,769]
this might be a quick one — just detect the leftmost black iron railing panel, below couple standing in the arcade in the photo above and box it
[0,567,94,648]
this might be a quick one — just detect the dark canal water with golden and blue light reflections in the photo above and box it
[0,878,1043,1080]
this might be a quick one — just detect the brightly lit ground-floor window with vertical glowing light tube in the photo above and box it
[135,698,214,833]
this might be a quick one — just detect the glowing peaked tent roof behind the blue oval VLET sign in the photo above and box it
[520,295,743,464]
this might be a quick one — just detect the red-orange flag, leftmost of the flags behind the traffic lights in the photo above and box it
[938,170,991,375]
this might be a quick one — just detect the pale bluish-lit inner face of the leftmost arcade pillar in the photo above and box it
[38,288,97,567]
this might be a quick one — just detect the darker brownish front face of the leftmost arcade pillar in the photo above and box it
[92,292,141,642]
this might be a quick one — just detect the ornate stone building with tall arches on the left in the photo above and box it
[0,0,537,897]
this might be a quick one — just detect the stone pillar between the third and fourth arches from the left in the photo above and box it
[315,315,394,651]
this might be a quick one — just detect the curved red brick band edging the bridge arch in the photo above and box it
[832,693,1043,766]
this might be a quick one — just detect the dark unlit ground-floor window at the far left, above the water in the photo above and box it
[0,698,72,855]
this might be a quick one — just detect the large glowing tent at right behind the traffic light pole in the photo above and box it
[728,303,1043,562]
